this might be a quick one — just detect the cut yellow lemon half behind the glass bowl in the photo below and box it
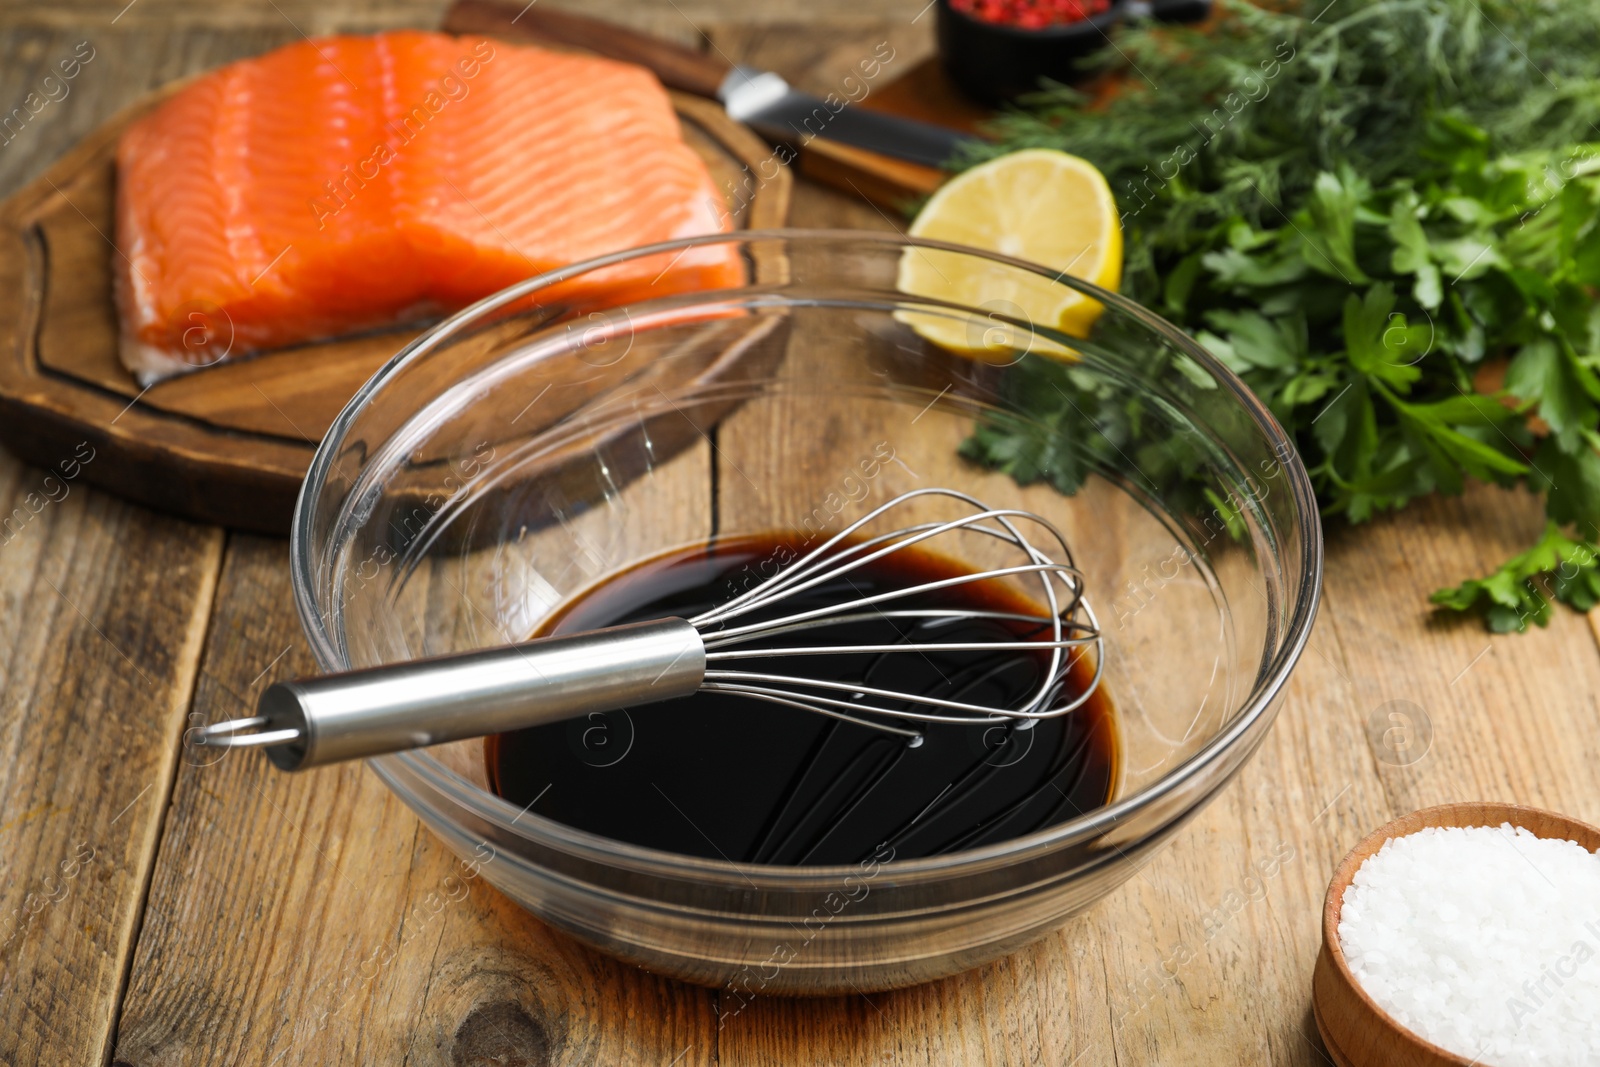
[896,149,1122,363]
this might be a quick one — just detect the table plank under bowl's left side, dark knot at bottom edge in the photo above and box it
[115,443,715,1067]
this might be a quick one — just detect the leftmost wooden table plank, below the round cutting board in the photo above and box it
[0,453,222,1064]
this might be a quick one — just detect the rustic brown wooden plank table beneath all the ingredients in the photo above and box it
[0,0,1600,1067]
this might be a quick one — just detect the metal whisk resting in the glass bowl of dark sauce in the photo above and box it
[195,490,1104,771]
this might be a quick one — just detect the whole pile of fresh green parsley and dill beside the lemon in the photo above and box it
[963,0,1600,630]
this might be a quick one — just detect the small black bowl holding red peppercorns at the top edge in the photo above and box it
[939,0,1211,107]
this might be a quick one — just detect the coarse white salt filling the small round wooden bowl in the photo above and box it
[1339,822,1600,1067]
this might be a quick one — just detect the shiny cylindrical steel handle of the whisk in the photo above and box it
[258,619,706,771]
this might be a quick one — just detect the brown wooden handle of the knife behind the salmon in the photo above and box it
[443,0,733,99]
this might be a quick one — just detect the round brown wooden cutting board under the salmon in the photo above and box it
[0,86,790,533]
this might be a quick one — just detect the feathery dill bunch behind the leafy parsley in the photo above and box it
[965,0,1600,301]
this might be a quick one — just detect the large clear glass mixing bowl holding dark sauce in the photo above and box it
[291,230,1322,991]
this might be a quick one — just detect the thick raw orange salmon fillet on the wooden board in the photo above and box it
[115,32,744,384]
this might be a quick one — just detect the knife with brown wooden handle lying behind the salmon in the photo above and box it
[443,0,974,166]
